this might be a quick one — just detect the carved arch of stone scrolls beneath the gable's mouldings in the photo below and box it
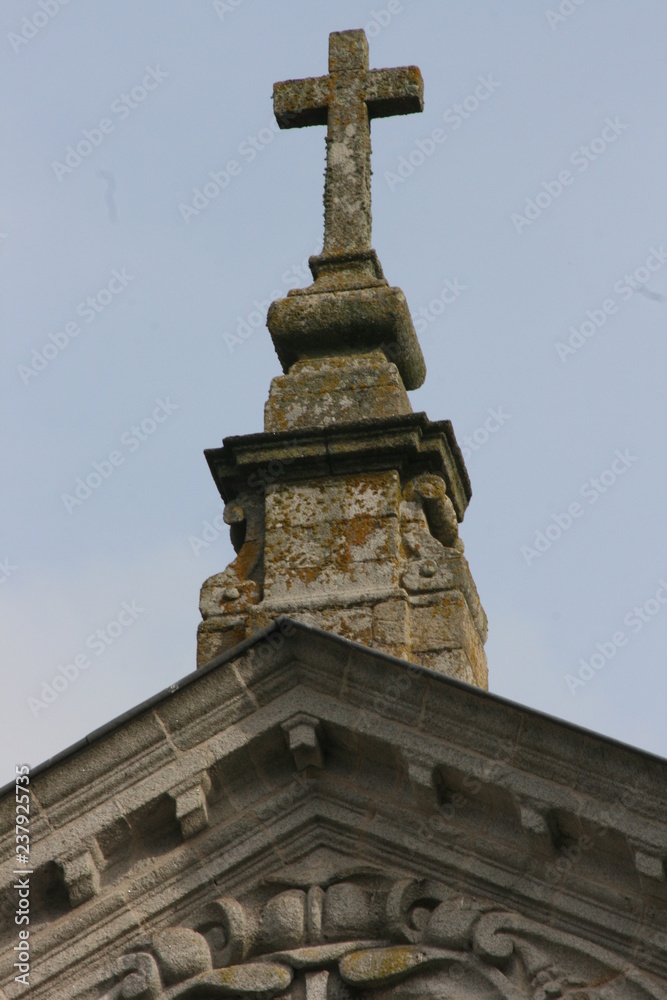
[104,877,667,1000]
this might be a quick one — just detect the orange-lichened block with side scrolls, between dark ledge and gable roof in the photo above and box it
[198,462,488,688]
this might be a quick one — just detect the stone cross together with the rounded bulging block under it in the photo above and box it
[266,31,426,390]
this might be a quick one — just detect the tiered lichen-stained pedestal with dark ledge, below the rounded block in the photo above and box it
[198,336,487,688]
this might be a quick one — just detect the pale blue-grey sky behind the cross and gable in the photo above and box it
[0,0,667,782]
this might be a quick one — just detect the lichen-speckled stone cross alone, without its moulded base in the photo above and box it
[273,30,424,276]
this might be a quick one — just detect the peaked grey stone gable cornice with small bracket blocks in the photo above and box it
[0,619,667,996]
